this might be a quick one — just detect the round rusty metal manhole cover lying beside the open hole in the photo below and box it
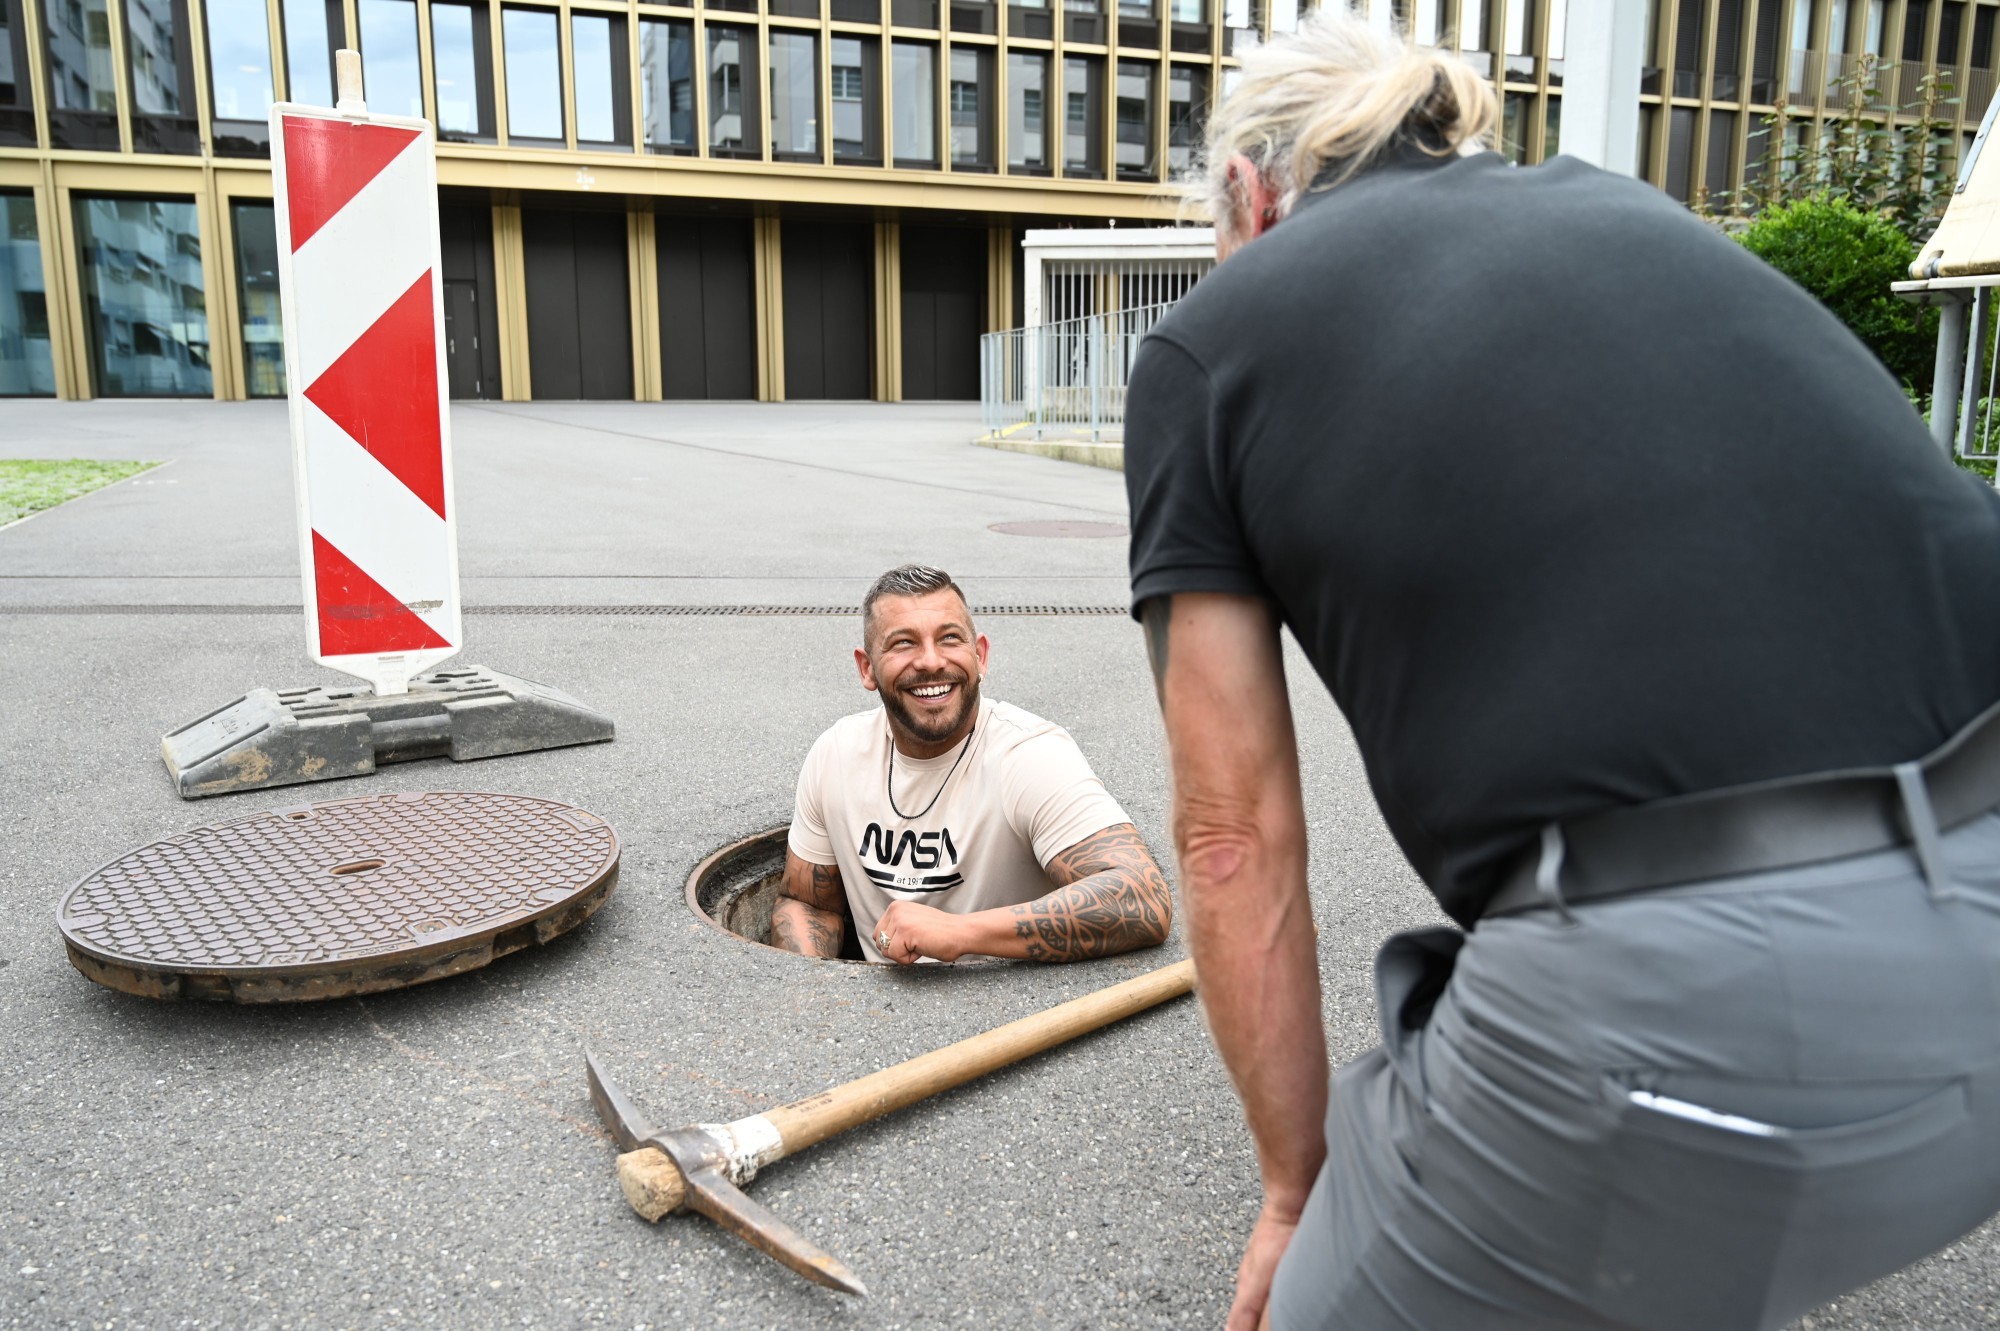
[58,791,618,1003]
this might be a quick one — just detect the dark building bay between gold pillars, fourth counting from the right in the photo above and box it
[520,208,632,402]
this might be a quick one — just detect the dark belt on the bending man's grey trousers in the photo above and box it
[1484,687,2000,915]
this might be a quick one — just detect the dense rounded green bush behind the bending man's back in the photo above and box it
[1736,194,1938,394]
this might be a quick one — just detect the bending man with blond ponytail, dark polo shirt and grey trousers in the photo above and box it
[1126,16,2000,1331]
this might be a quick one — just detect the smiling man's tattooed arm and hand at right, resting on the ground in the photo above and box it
[882,823,1174,961]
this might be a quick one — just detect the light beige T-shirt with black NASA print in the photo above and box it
[790,697,1132,961]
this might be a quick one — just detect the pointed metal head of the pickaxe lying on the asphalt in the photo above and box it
[584,1053,868,1295]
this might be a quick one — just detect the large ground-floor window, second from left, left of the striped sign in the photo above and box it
[76,196,214,398]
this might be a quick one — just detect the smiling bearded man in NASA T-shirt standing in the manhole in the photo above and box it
[770,564,1174,965]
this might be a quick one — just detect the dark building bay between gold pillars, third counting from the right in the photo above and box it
[652,214,756,400]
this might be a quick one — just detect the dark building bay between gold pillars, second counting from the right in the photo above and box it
[778,218,874,400]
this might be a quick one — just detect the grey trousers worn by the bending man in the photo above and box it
[1270,813,2000,1331]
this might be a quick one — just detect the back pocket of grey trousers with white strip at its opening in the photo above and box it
[1588,1073,1976,1331]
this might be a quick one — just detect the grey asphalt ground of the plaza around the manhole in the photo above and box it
[0,402,2000,1331]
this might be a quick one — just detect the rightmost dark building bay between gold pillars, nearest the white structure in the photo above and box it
[902,226,986,402]
